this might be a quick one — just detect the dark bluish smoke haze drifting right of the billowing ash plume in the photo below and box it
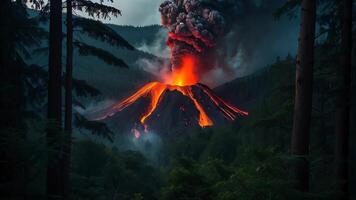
[206,0,298,83]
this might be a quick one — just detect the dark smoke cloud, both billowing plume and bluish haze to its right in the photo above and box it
[159,0,298,86]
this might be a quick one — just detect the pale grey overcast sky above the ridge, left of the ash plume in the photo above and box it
[86,0,164,26]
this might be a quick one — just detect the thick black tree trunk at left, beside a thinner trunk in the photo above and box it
[47,0,63,199]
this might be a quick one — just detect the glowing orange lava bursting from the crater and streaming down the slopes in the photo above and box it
[97,56,248,129]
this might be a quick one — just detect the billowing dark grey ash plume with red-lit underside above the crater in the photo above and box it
[159,0,225,68]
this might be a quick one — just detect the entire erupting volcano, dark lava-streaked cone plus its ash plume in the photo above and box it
[91,0,248,137]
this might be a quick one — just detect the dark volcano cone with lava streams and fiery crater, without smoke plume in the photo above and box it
[95,56,248,136]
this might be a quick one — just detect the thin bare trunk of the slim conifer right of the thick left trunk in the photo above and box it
[63,0,73,199]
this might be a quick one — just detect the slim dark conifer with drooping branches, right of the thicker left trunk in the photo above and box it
[63,0,134,199]
